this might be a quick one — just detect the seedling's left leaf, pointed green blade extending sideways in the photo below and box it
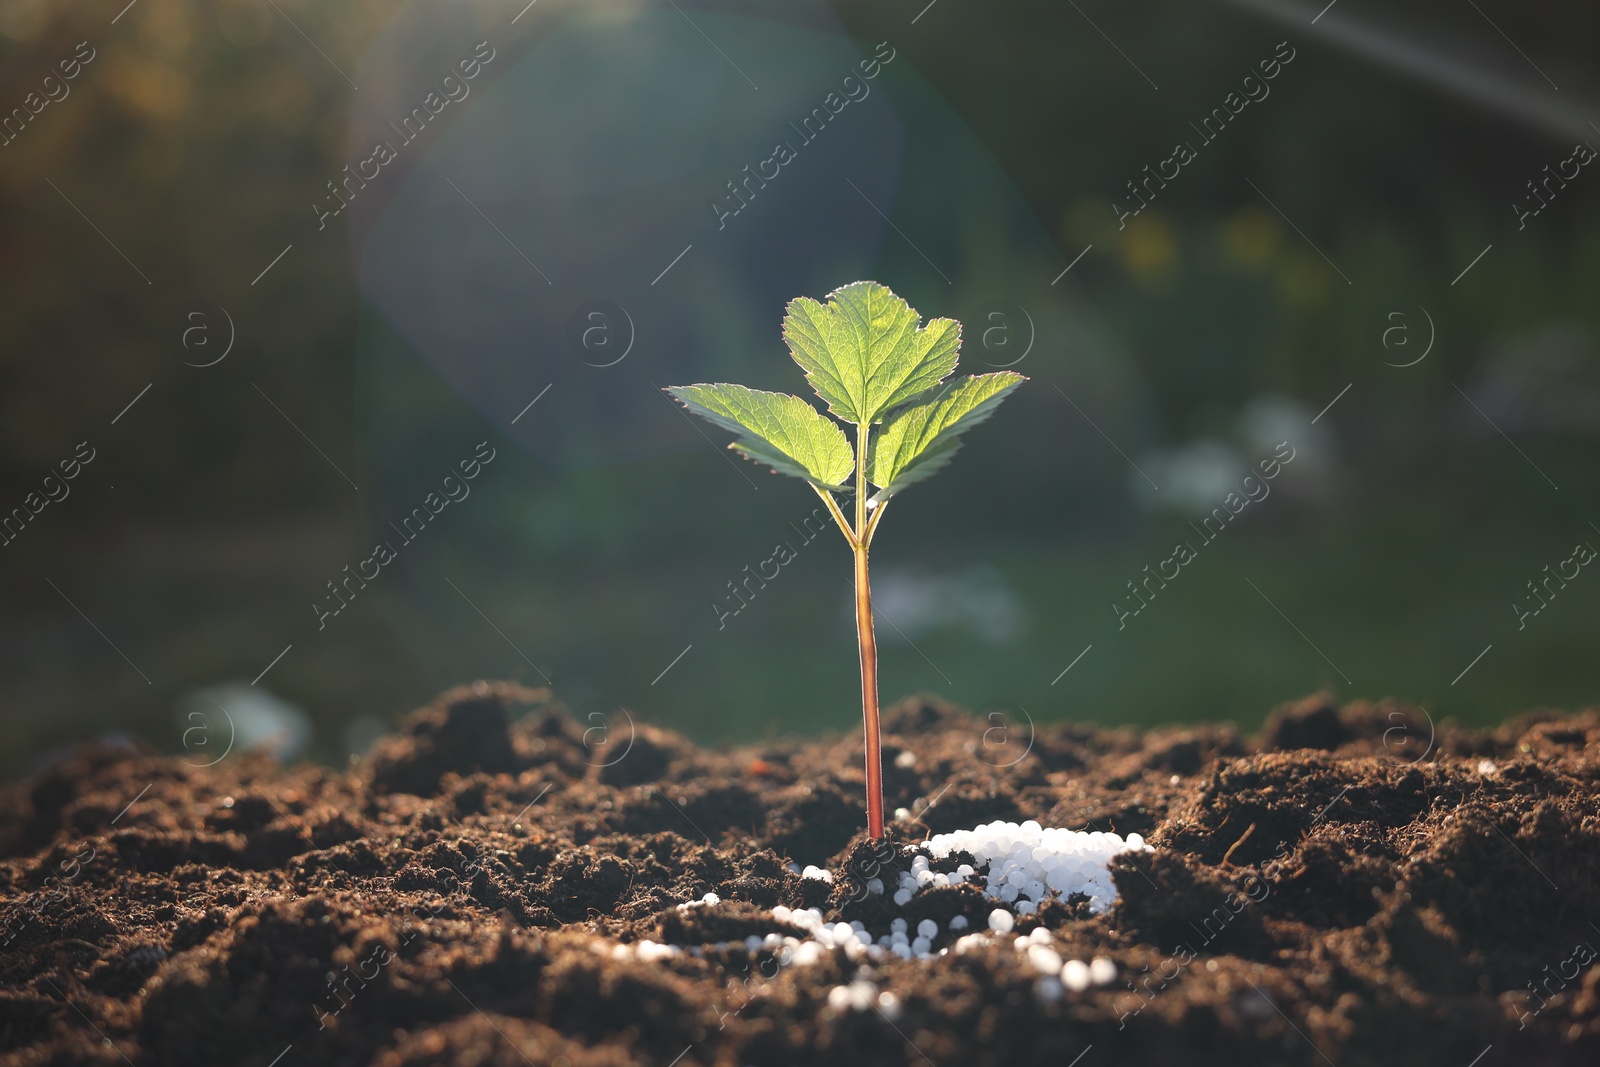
[667,382,856,490]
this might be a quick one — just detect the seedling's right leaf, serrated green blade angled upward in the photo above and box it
[867,371,1027,502]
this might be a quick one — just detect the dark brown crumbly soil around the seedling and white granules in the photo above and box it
[0,683,1600,1067]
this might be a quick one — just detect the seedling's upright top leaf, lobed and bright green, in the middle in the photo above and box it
[784,282,962,422]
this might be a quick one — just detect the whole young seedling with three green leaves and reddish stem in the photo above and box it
[667,282,1027,838]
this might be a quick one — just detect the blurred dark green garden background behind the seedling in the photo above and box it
[0,0,1600,776]
